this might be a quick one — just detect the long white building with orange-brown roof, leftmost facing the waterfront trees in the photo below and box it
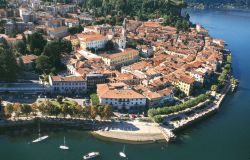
[49,76,87,94]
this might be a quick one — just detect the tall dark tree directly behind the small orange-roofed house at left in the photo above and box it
[28,32,47,55]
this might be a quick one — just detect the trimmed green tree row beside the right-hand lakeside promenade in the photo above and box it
[148,94,210,120]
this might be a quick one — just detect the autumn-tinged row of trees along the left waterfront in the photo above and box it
[4,101,113,120]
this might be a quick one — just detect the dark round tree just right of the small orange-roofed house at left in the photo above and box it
[35,55,52,74]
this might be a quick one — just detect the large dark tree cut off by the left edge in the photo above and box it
[0,48,20,82]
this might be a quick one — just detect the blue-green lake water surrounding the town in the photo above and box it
[0,10,250,160]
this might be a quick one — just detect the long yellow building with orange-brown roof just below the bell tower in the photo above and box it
[101,48,140,68]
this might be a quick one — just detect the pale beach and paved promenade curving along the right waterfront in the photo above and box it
[93,85,231,143]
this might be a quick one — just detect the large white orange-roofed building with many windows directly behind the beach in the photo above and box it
[97,83,146,113]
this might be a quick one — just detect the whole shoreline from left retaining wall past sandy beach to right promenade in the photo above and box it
[0,85,231,144]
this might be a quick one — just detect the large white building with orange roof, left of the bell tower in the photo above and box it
[77,32,108,50]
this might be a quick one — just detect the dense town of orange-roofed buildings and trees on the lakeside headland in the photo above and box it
[0,0,238,142]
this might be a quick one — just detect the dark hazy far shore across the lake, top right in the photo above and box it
[186,0,250,9]
